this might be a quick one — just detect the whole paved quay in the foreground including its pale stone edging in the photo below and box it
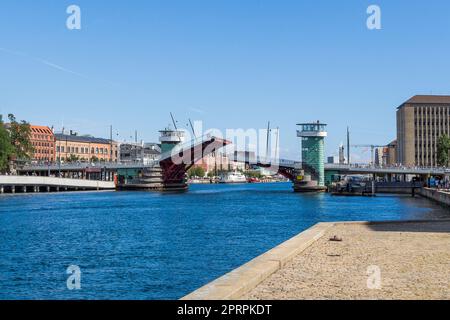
[185,219,450,300]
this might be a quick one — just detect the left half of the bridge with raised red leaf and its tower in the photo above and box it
[15,129,230,191]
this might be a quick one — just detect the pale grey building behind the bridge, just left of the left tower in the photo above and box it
[119,143,161,165]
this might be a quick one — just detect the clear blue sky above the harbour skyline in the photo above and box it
[0,0,450,158]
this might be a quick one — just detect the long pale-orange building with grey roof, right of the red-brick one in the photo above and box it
[55,131,118,162]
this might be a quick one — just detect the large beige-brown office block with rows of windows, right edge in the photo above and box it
[396,95,450,166]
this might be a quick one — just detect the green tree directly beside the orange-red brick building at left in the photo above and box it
[8,114,34,160]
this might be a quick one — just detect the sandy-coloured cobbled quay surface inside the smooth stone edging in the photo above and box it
[242,221,450,300]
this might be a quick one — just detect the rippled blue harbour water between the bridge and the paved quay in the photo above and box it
[0,184,450,299]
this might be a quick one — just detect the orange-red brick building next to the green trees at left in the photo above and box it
[30,125,55,162]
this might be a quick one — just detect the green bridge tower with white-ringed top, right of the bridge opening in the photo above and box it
[294,121,328,192]
